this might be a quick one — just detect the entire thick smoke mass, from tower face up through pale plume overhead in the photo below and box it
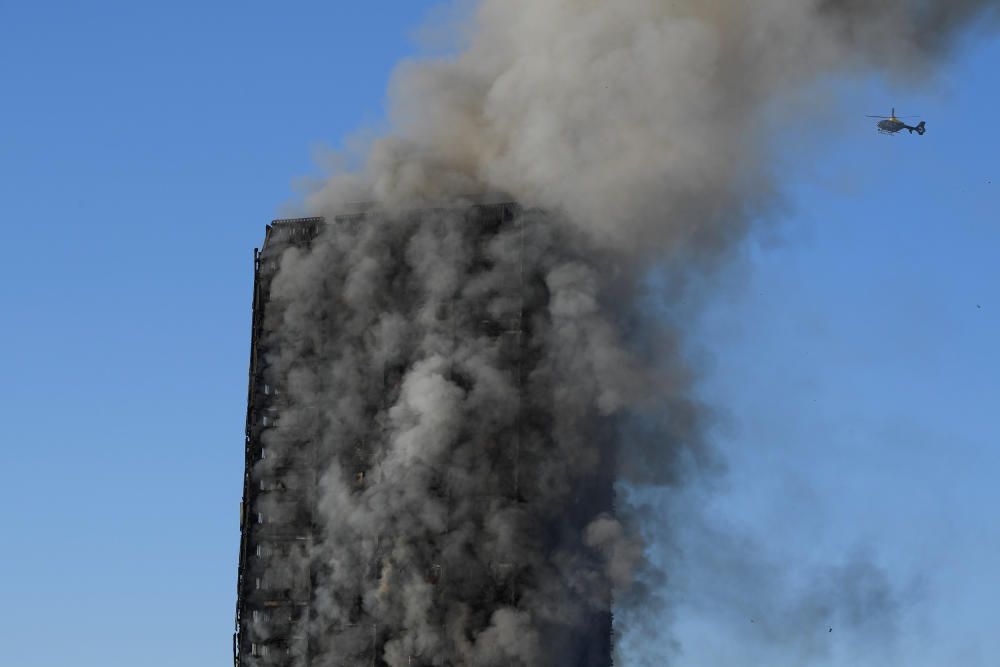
[263,0,993,667]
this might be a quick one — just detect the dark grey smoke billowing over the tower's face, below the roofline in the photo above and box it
[265,208,659,665]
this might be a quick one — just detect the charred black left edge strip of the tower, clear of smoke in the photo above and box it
[233,218,323,667]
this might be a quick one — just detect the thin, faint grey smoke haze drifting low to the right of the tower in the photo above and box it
[631,490,925,666]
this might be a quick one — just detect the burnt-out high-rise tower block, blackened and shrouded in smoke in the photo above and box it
[233,203,615,667]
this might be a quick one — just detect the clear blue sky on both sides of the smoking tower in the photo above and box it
[0,0,1000,667]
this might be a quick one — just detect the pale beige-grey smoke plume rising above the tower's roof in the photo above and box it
[312,0,996,256]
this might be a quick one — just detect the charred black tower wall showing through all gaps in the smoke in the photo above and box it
[233,204,614,667]
